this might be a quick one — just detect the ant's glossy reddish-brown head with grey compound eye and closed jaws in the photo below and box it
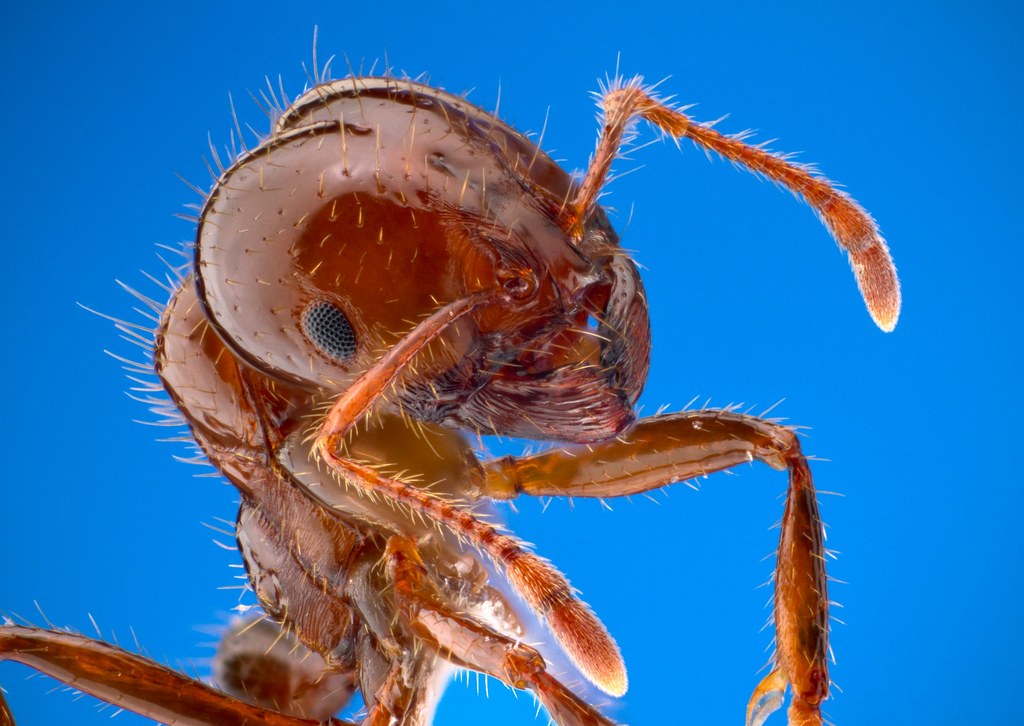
[196,79,649,440]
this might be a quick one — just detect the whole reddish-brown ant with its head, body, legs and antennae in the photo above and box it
[0,69,900,724]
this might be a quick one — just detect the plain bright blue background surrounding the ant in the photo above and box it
[0,1,1024,726]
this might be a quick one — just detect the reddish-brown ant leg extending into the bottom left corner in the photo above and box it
[0,625,352,726]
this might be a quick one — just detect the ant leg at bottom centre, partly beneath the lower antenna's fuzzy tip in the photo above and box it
[385,536,613,726]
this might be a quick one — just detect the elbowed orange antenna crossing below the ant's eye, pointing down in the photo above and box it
[312,291,627,695]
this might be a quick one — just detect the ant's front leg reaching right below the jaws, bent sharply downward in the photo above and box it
[482,411,828,726]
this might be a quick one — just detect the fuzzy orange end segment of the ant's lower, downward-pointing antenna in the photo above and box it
[547,600,629,697]
